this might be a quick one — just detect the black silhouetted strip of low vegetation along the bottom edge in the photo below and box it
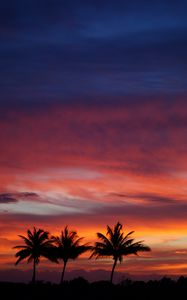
[0,277,187,300]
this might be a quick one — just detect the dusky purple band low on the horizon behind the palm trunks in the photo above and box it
[0,268,184,284]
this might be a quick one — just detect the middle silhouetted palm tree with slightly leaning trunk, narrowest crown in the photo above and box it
[53,226,90,284]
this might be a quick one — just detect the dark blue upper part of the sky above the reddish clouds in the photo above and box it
[0,0,187,105]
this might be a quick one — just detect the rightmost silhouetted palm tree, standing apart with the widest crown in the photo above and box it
[90,222,151,283]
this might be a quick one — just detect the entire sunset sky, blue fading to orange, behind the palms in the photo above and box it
[0,0,187,280]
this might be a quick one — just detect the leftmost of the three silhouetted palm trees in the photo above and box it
[13,227,58,283]
